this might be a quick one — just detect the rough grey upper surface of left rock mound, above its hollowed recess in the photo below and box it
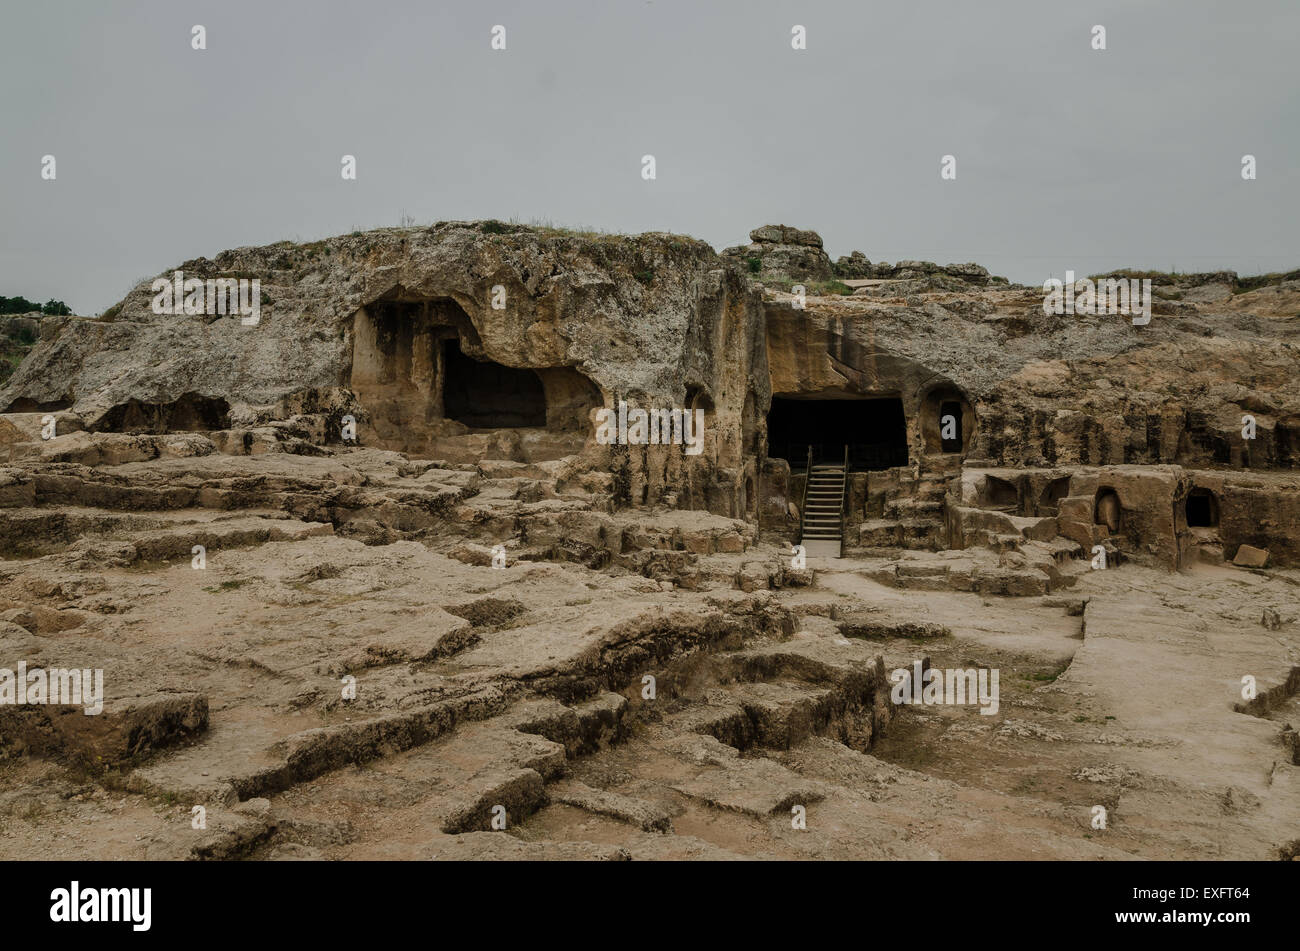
[0,222,761,427]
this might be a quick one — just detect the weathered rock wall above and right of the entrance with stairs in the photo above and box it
[767,280,1300,478]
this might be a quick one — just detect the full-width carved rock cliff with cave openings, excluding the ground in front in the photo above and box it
[0,221,1300,566]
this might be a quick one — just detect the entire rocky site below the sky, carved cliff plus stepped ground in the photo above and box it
[0,221,1300,860]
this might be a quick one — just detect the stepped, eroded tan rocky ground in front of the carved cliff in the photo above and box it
[0,433,1300,859]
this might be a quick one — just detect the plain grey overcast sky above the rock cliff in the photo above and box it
[0,0,1300,314]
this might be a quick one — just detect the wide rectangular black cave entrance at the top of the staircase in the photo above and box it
[767,396,907,472]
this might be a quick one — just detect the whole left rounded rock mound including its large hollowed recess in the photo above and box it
[0,222,767,509]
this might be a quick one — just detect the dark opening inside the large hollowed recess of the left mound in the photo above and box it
[442,340,546,429]
